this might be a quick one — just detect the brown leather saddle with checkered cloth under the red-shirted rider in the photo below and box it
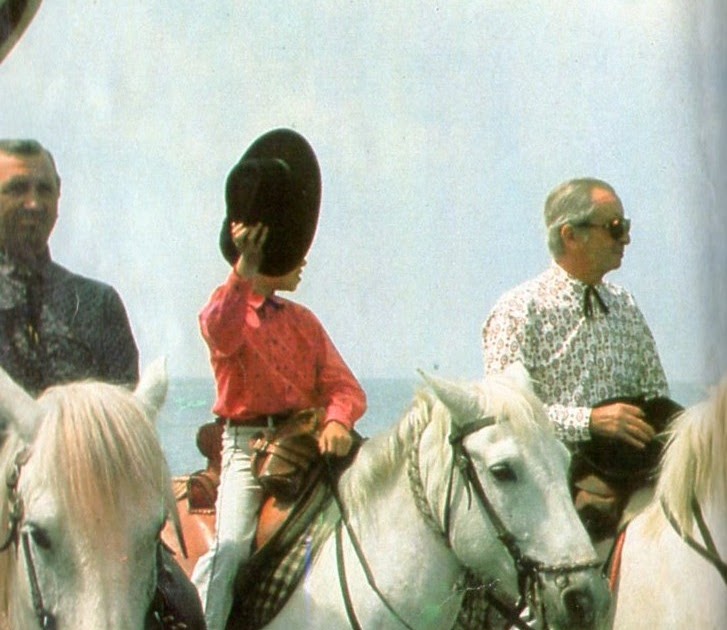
[227,410,363,630]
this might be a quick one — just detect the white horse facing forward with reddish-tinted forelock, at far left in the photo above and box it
[0,362,191,630]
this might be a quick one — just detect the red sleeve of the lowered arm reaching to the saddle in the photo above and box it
[318,326,367,430]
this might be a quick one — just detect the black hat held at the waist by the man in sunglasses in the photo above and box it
[574,396,684,482]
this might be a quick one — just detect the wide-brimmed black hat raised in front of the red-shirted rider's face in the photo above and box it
[220,129,321,276]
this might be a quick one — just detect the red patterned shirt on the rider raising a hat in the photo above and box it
[199,271,366,429]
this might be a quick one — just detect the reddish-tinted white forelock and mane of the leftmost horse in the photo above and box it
[0,382,174,564]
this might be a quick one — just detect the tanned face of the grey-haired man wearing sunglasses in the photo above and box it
[584,188,631,276]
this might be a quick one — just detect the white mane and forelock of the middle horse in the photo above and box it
[342,374,552,511]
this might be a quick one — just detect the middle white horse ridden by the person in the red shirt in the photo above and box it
[240,374,610,630]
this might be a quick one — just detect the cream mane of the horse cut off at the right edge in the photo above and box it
[655,377,727,532]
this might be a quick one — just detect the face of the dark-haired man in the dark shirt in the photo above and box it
[0,151,60,259]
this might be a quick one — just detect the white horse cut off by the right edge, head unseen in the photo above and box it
[614,378,727,630]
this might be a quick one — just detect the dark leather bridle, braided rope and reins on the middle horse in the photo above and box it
[334,416,600,630]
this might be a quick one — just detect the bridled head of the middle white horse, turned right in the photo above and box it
[423,366,609,628]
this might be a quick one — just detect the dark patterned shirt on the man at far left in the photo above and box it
[0,252,139,395]
